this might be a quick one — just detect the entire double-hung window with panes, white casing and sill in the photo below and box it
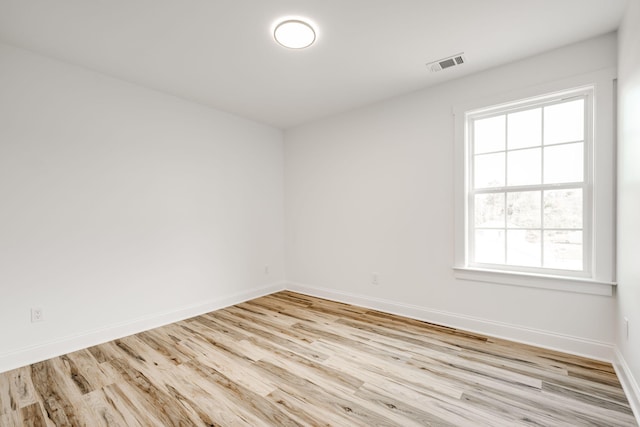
[454,69,615,295]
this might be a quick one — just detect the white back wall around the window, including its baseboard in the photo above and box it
[285,34,616,359]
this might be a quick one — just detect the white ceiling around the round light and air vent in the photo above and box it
[0,0,627,128]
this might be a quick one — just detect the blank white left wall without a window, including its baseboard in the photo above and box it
[0,41,284,371]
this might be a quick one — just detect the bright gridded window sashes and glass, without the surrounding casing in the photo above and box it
[466,89,593,276]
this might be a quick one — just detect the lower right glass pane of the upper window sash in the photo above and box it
[544,142,584,184]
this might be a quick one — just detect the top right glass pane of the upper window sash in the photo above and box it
[544,99,584,145]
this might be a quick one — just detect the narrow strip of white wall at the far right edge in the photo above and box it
[615,0,640,419]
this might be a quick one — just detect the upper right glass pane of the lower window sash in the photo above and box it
[544,189,582,228]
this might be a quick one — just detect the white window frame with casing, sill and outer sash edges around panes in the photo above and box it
[453,69,615,295]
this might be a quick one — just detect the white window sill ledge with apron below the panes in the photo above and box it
[453,267,616,296]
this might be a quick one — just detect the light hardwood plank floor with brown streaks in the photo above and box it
[0,292,636,426]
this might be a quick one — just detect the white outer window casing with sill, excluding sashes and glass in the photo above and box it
[453,68,616,295]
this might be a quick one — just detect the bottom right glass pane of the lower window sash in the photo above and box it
[543,231,582,270]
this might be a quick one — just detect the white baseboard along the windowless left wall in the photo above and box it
[0,282,285,373]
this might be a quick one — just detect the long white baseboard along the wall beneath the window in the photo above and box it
[287,283,613,362]
